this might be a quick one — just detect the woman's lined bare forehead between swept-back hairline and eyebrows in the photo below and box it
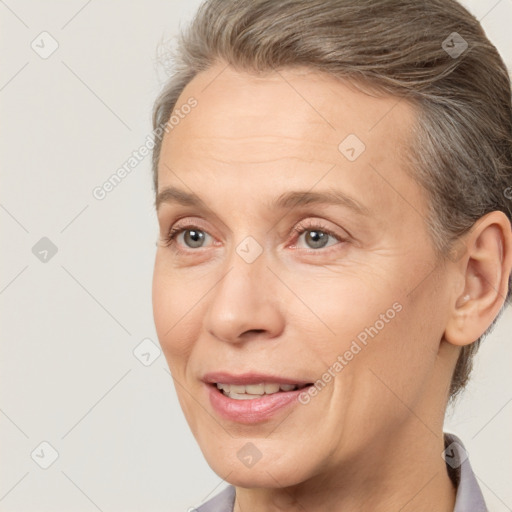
[159,64,423,226]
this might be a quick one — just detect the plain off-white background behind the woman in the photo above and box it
[0,0,512,512]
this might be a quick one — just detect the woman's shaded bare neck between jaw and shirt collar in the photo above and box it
[234,417,456,512]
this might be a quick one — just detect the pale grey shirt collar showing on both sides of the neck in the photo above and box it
[196,433,488,512]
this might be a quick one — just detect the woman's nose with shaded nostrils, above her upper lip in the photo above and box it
[203,243,284,343]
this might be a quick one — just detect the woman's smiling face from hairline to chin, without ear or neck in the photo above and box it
[153,65,452,487]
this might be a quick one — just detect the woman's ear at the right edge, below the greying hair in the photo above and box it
[444,211,512,346]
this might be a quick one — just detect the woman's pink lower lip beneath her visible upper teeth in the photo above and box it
[206,384,303,424]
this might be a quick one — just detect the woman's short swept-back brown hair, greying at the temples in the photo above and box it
[153,0,512,400]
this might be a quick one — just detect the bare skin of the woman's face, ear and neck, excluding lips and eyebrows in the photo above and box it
[153,63,512,512]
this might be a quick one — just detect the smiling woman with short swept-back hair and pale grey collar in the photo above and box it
[153,0,512,512]
